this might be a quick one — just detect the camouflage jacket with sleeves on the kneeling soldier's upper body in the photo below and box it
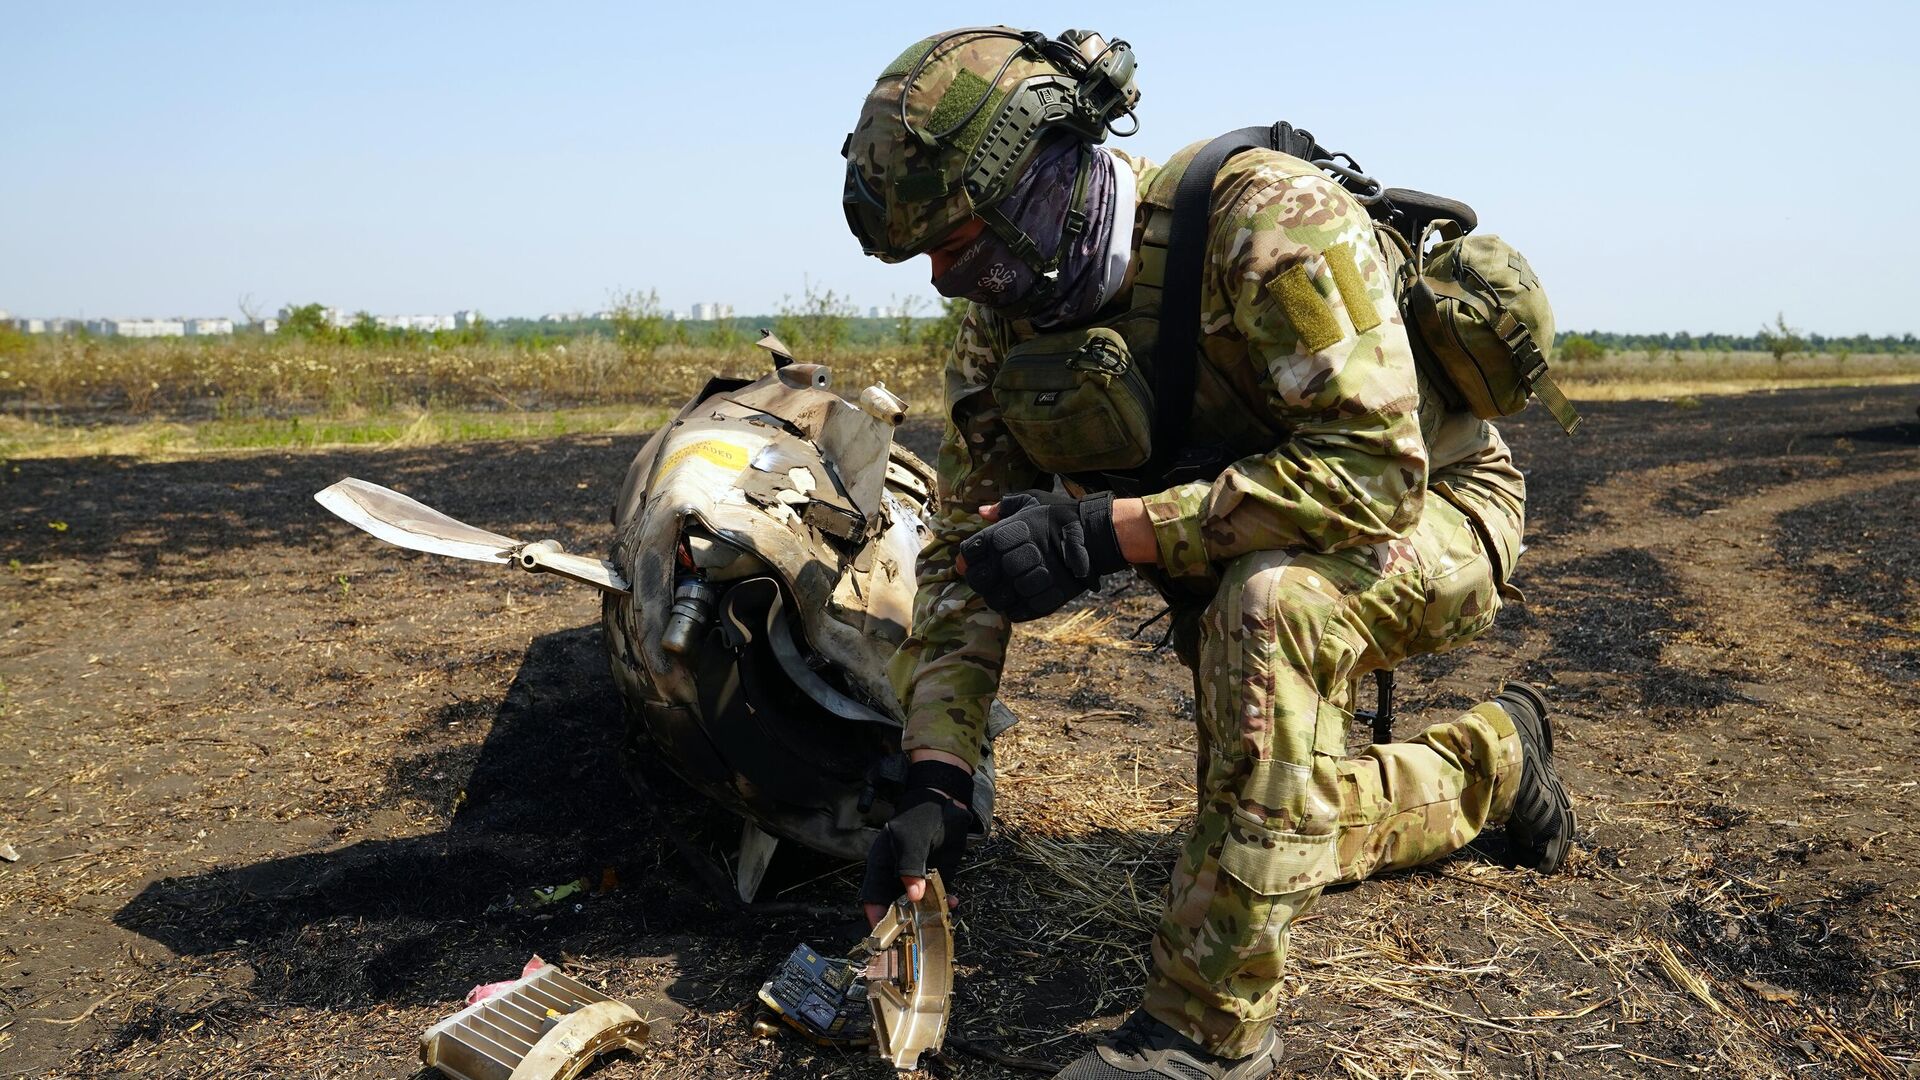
[889,144,1524,765]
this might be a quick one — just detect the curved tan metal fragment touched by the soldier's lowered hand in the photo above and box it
[854,871,954,1072]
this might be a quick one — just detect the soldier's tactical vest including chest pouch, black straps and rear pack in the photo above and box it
[993,123,1578,494]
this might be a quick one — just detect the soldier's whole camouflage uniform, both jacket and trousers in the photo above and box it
[893,148,1524,1055]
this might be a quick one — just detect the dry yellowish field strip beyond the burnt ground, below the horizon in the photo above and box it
[0,331,1920,430]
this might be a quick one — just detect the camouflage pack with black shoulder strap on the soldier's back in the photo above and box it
[1148,121,1580,445]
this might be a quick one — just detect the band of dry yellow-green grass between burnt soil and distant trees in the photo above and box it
[0,334,1920,457]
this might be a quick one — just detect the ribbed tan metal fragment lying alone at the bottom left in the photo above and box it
[420,967,649,1080]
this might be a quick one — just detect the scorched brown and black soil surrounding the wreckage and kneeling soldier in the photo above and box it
[0,388,1920,1080]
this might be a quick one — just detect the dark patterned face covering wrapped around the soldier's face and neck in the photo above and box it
[933,138,1116,327]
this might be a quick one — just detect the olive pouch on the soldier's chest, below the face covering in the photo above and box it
[993,327,1154,473]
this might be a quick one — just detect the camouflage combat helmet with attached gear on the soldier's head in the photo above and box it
[841,27,1140,263]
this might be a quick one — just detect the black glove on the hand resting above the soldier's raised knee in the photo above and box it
[960,492,1127,623]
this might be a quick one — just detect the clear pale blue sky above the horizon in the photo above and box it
[0,0,1920,334]
